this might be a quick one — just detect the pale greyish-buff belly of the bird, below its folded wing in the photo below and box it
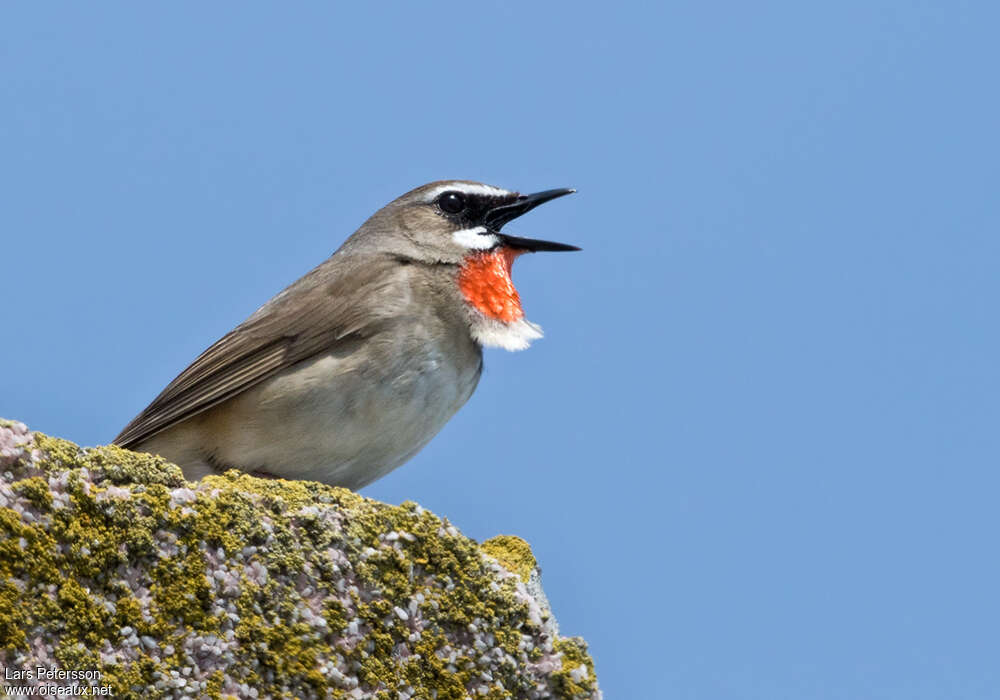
[170,350,480,489]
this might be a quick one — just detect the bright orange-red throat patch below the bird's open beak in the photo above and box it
[458,247,524,323]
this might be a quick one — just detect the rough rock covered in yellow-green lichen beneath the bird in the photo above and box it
[0,421,600,700]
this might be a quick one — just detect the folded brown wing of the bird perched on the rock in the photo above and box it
[114,256,409,447]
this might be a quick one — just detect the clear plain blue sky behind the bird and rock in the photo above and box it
[0,1,1000,700]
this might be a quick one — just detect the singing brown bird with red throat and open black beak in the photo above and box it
[113,180,580,490]
